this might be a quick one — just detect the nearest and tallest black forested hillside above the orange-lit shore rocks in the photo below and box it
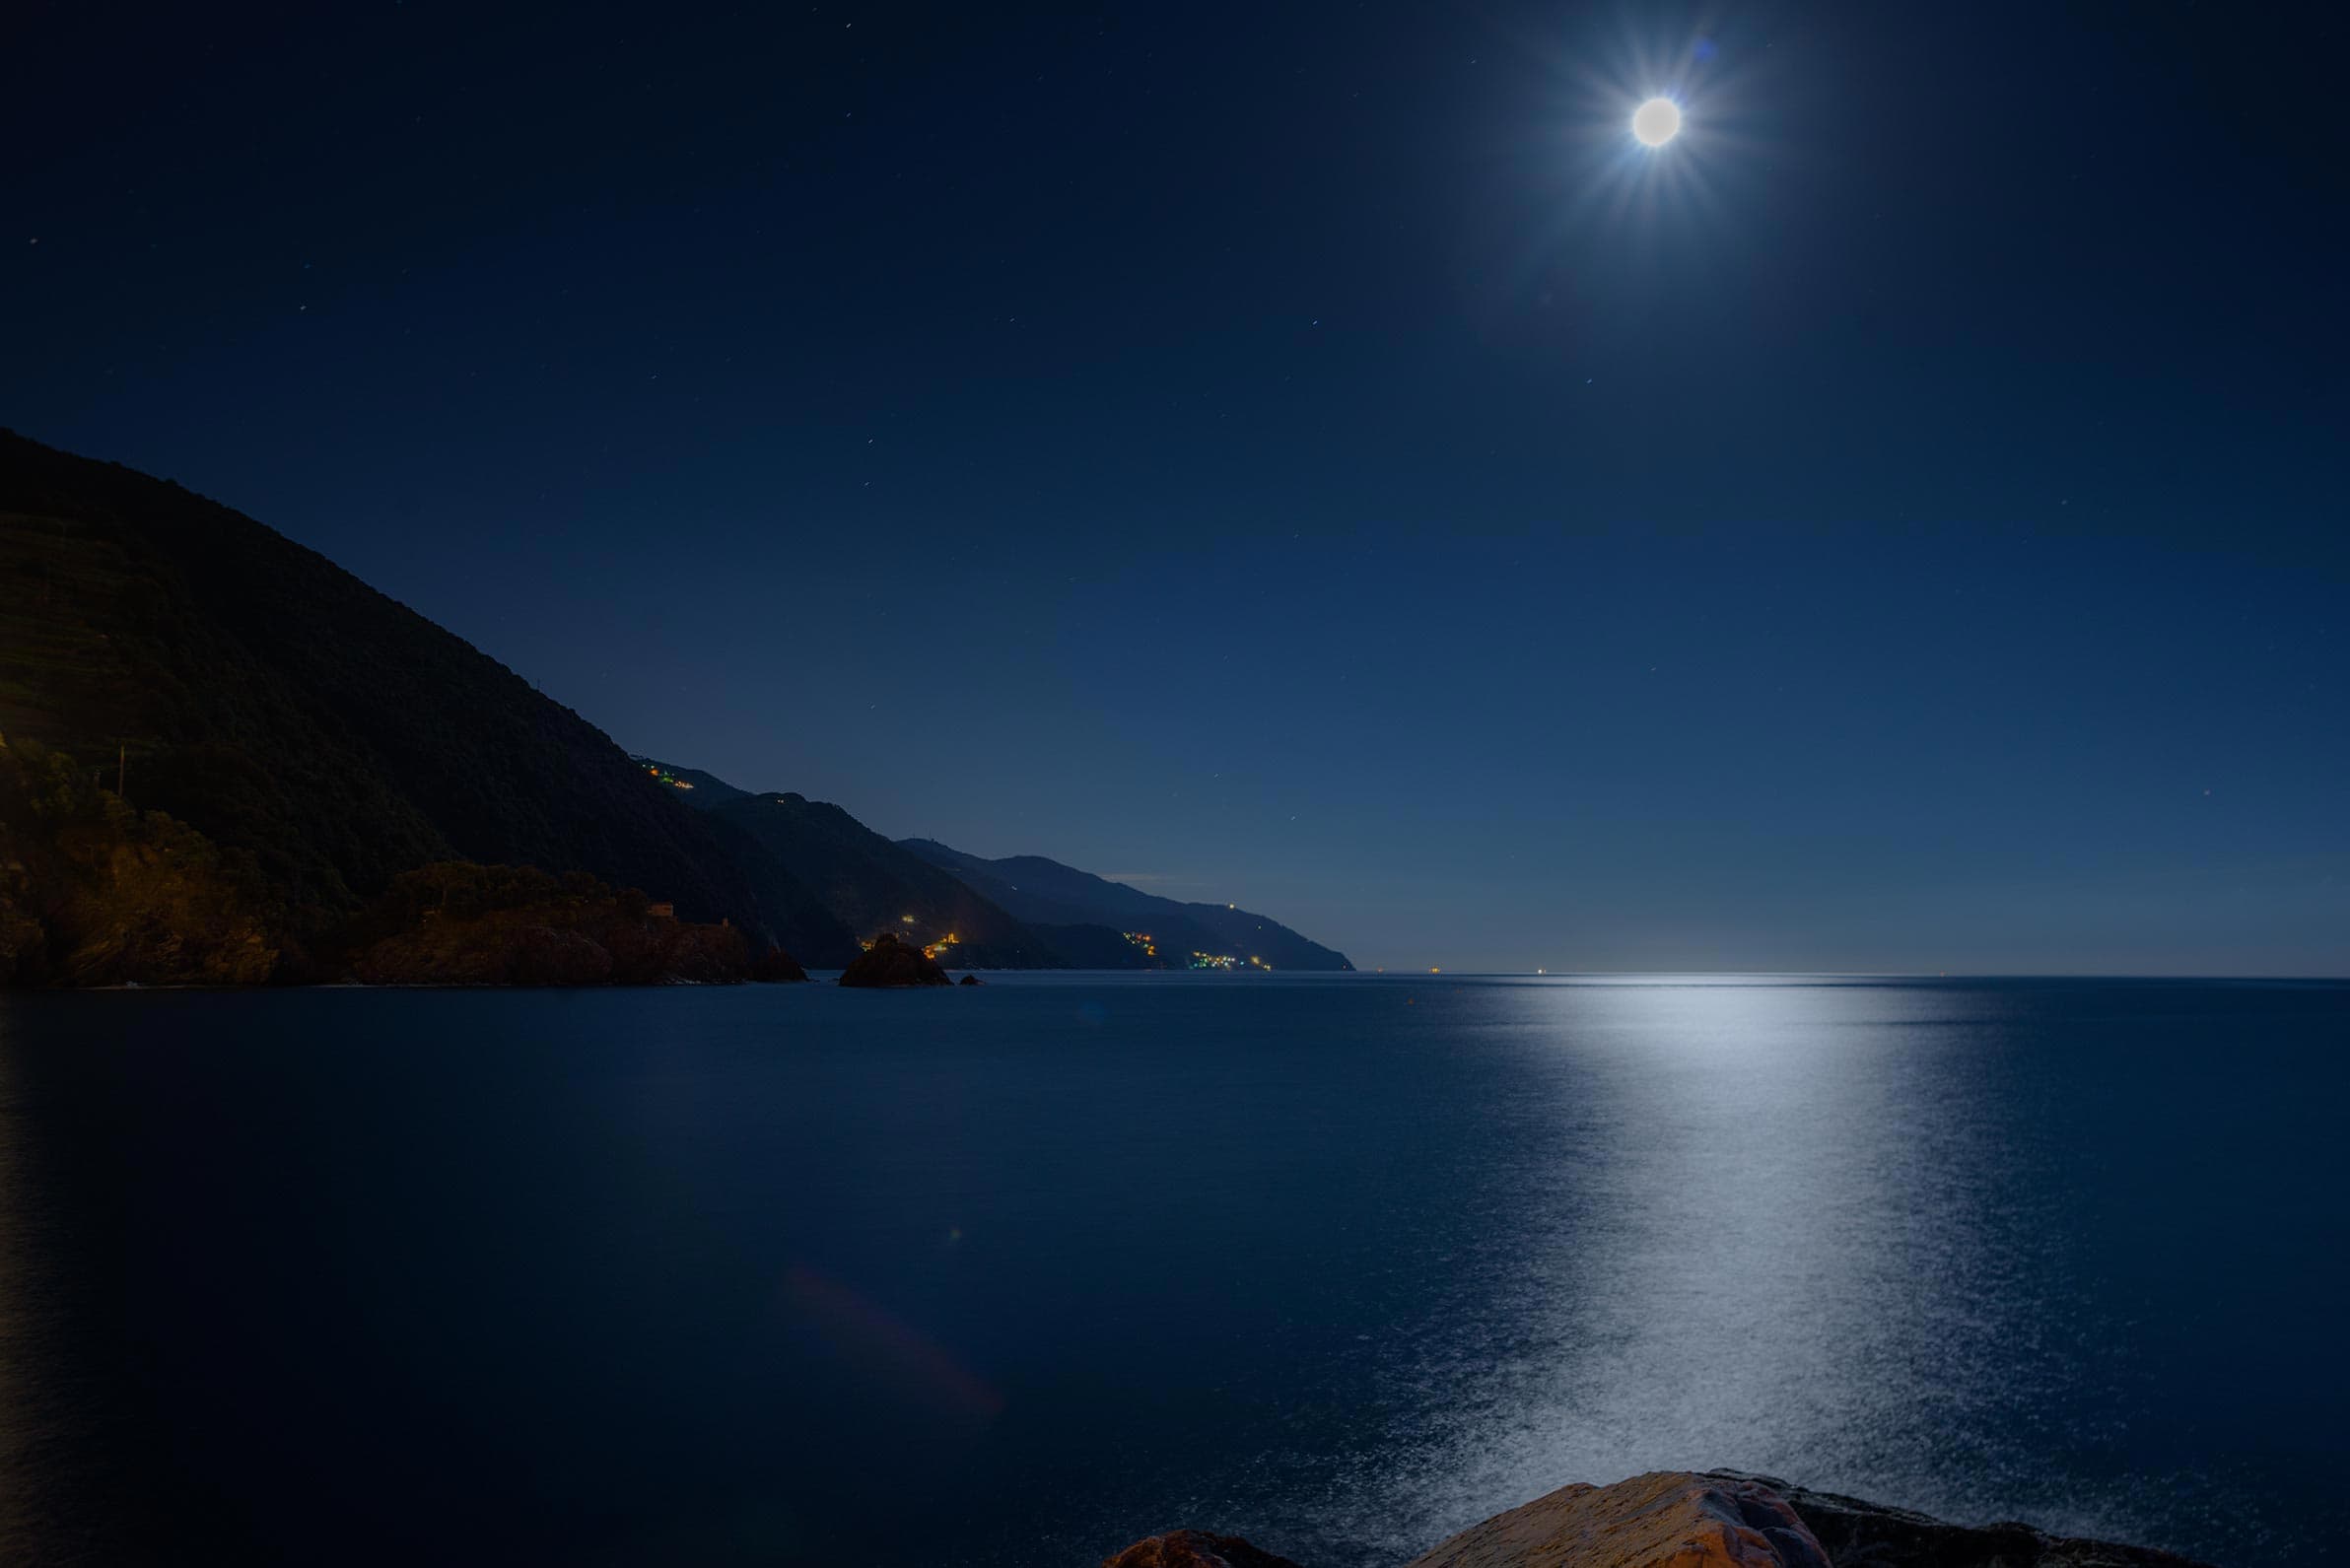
[0,433,856,964]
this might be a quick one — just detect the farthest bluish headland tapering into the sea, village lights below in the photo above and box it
[900,840,1353,971]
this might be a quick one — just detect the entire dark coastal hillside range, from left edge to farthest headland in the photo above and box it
[0,431,1347,983]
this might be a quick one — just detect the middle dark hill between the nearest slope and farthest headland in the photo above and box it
[637,757,1067,969]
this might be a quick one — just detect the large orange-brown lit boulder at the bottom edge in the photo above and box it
[1410,1474,1829,1568]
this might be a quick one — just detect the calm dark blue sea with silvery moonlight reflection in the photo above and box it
[0,976,2350,1568]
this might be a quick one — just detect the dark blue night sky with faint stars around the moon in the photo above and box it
[0,2,2350,974]
